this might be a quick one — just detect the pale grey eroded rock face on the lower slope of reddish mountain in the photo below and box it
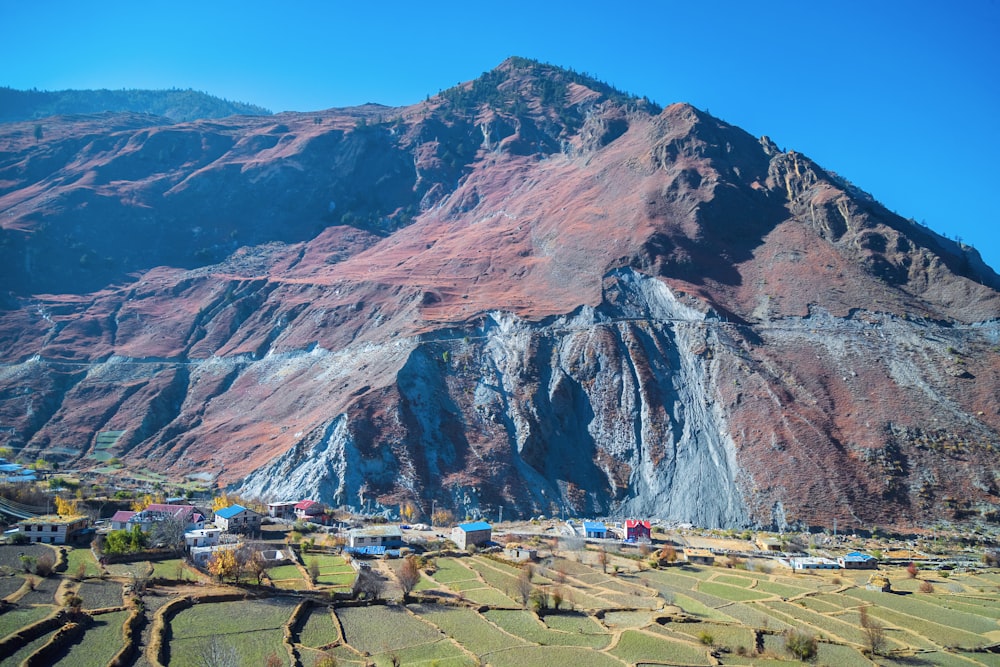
[232,270,750,526]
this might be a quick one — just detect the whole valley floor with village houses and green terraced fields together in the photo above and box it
[0,474,1000,667]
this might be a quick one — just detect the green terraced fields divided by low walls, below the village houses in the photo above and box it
[0,547,1000,667]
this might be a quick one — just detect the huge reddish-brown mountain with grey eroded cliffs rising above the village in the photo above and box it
[0,58,1000,529]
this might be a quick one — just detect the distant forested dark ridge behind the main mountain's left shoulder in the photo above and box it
[0,87,271,124]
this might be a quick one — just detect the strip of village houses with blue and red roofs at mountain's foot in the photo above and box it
[0,496,994,590]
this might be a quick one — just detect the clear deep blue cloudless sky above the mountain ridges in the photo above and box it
[0,0,1000,271]
